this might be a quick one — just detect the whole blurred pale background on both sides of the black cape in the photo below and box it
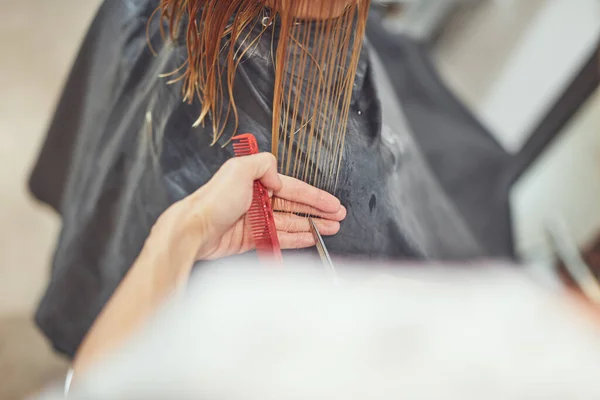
[0,0,600,400]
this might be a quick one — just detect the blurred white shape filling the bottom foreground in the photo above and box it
[36,261,600,400]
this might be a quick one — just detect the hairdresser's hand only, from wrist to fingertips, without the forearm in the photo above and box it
[155,153,346,260]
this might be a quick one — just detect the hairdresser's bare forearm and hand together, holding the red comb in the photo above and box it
[75,153,346,375]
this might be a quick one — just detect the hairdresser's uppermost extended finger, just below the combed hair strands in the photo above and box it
[275,175,341,213]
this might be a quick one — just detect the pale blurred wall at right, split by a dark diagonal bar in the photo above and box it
[435,0,600,256]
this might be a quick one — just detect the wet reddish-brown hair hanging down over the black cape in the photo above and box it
[160,0,370,189]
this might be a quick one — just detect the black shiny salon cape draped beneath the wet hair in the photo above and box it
[30,0,512,356]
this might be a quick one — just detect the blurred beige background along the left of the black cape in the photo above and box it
[0,0,100,400]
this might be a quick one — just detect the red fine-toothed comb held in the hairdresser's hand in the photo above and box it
[232,133,282,261]
